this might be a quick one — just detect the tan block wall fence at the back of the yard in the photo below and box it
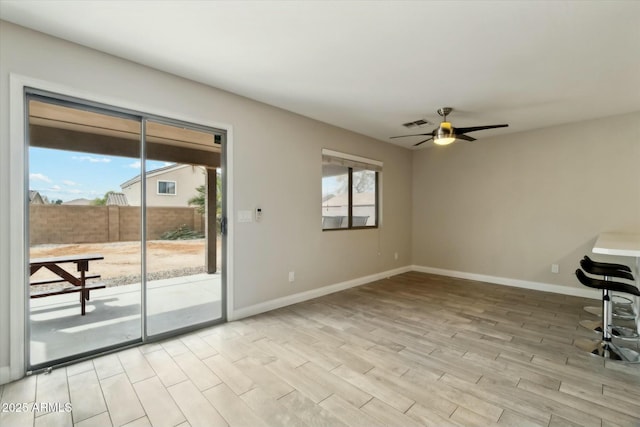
[29,204,204,245]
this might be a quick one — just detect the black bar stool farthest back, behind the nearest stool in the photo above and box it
[579,257,639,340]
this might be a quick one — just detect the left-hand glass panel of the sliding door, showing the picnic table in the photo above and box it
[28,96,142,366]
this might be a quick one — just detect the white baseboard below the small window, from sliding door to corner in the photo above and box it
[227,266,411,321]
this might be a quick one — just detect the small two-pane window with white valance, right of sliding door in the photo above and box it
[322,150,382,230]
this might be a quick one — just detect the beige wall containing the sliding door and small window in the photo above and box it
[0,22,411,382]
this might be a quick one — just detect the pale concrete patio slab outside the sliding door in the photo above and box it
[30,274,222,365]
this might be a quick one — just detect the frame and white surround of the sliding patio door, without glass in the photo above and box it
[16,84,232,379]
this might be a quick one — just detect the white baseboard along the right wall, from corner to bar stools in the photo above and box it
[411,265,602,300]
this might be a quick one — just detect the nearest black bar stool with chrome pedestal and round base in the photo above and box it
[576,269,640,363]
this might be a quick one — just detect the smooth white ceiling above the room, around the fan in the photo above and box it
[0,0,640,147]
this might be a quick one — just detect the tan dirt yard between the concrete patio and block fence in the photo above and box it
[30,239,221,284]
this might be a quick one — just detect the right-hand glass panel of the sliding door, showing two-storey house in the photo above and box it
[145,120,222,335]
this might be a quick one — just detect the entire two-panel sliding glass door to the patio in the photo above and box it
[25,93,225,369]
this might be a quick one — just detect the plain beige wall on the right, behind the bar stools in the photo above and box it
[412,113,640,287]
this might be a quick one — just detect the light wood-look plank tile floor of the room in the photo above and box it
[0,273,640,427]
